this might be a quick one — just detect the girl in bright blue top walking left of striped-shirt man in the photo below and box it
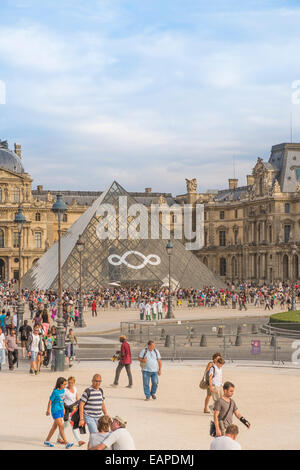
[44,377,74,449]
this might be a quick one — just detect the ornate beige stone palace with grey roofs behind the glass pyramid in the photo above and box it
[0,140,300,283]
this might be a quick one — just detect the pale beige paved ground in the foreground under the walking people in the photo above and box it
[0,361,300,450]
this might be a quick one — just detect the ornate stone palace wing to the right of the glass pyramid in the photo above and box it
[193,144,300,283]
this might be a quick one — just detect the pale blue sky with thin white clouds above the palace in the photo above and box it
[0,0,300,195]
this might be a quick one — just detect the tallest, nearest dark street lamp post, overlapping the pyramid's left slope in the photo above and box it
[52,194,67,371]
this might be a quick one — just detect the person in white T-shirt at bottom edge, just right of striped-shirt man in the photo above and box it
[90,416,136,450]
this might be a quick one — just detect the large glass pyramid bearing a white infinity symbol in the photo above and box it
[23,182,224,291]
